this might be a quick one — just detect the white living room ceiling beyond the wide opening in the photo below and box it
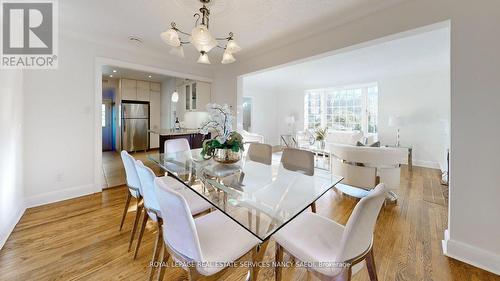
[243,28,450,91]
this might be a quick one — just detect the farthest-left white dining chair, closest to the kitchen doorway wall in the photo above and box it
[120,150,143,251]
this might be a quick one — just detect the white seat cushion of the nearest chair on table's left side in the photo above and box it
[195,211,260,276]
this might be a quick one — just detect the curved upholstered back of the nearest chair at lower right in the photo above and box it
[338,184,387,262]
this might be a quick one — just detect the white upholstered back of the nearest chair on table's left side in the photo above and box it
[154,178,204,262]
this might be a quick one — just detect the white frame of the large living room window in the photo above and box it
[304,82,379,135]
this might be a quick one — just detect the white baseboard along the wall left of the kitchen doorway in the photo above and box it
[25,184,100,208]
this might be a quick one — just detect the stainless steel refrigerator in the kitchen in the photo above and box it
[121,103,149,151]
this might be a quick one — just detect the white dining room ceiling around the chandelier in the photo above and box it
[59,0,403,61]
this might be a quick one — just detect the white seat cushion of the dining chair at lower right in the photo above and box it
[273,212,344,276]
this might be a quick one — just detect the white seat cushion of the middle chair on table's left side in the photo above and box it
[146,176,212,220]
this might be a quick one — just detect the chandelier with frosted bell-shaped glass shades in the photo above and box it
[160,0,241,64]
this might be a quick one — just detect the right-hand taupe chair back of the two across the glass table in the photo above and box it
[281,148,314,176]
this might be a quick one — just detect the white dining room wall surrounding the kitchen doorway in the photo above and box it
[24,34,211,206]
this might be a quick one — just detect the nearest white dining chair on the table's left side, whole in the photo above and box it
[155,179,260,280]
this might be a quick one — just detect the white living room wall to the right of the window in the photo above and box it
[378,70,450,169]
